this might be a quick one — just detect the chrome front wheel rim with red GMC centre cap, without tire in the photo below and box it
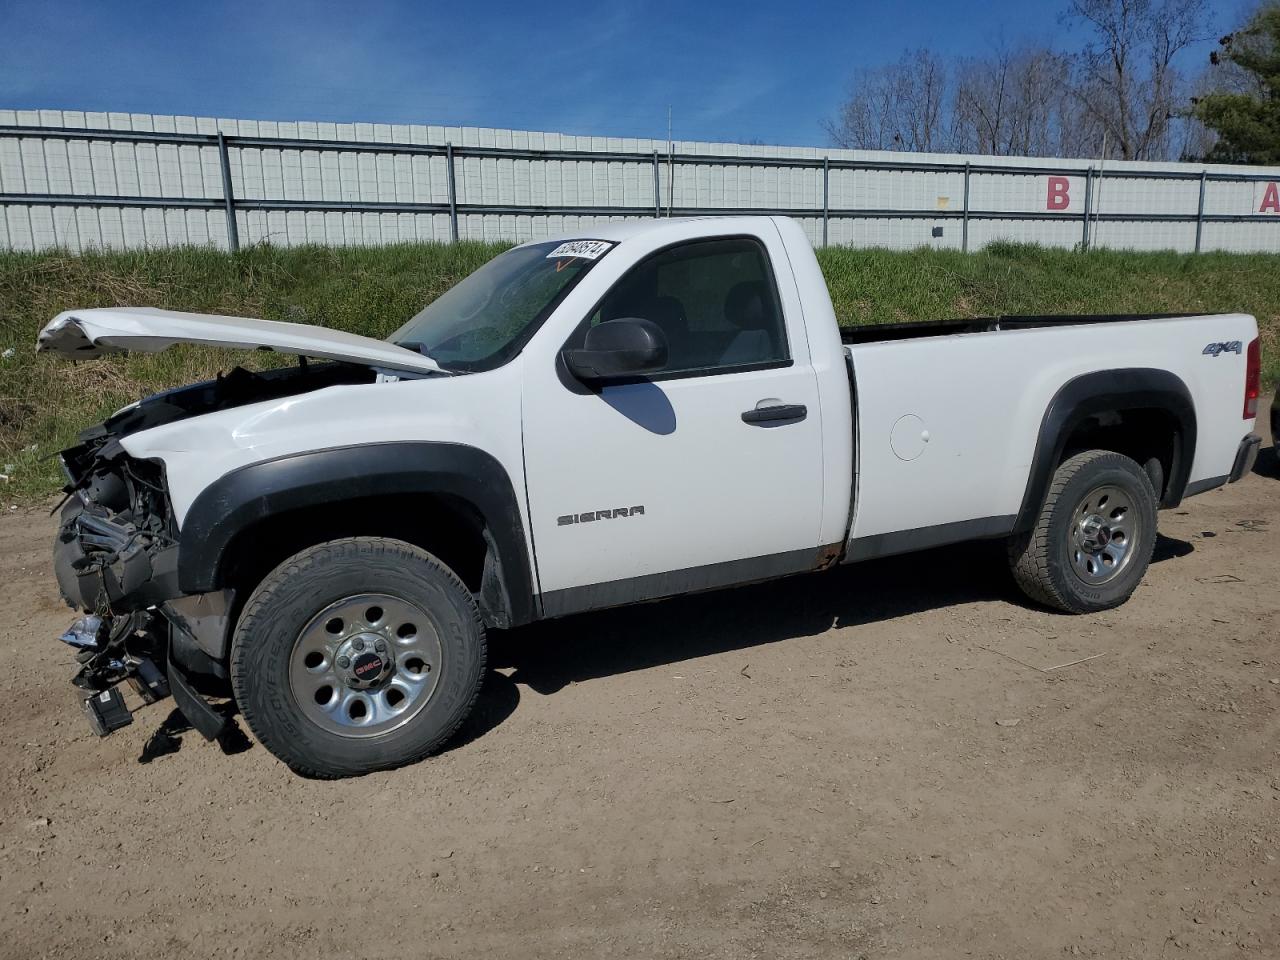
[289,594,443,737]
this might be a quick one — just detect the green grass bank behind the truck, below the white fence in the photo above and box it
[0,243,1280,502]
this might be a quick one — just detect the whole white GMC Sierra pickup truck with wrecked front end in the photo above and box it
[38,218,1260,777]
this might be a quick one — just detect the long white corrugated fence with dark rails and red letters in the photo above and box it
[0,110,1280,252]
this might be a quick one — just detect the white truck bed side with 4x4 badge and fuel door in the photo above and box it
[841,314,1257,549]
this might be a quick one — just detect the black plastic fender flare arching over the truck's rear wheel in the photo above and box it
[1014,367,1196,534]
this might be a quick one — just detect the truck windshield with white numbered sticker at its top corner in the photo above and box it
[388,241,613,371]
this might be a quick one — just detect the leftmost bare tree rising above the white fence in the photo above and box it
[823,50,951,152]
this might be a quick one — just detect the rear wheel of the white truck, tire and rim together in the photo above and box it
[1009,451,1156,613]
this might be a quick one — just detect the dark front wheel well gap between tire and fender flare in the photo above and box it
[220,494,495,618]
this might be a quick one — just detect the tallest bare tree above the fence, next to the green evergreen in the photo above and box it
[1068,0,1207,160]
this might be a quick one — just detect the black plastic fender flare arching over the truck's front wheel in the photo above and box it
[178,442,538,626]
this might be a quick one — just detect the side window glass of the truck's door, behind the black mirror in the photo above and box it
[591,238,790,374]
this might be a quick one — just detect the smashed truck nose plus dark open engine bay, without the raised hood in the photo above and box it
[54,360,389,739]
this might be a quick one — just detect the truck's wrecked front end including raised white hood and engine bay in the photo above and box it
[36,307,447,739]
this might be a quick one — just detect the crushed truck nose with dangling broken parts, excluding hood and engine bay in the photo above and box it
[54,421,230,739]
